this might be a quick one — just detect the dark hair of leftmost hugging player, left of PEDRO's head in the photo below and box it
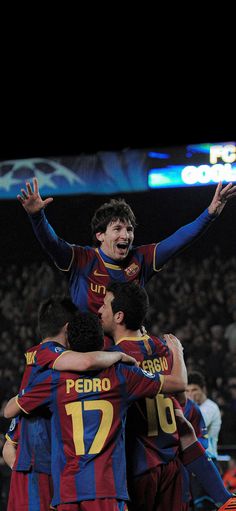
[38,295,77,339]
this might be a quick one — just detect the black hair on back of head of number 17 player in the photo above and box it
[67,311,104,353]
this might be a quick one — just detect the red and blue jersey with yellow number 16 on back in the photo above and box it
[111,335,181,476]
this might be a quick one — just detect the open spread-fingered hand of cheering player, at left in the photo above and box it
[17,177,53,215]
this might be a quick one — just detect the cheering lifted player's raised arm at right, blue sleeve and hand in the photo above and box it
[155,183,236,270]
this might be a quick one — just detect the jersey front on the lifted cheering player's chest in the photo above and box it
[70,244,157,313]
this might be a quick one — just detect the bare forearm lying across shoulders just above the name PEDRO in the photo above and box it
[53,351,137,371]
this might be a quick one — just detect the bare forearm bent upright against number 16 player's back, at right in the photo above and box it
[162,334,188,393]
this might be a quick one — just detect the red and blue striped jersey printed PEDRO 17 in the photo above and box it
[18,364,163,505]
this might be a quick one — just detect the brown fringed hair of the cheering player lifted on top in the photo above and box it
[91,198,136,246]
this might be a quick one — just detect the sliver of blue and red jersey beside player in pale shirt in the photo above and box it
[183,398,208,449]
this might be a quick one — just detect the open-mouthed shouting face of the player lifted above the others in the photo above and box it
[96,220,134,261]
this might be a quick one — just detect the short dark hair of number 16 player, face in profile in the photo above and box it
[107,282,149,330]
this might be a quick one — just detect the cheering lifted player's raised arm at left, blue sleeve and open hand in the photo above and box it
[17,178,73,271]
